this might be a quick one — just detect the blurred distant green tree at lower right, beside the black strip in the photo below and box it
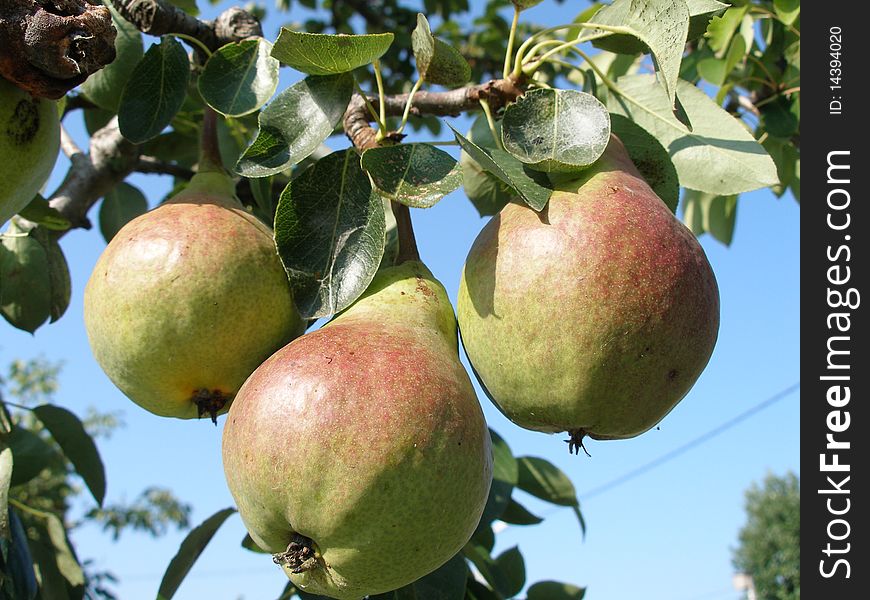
[733,473,801,600]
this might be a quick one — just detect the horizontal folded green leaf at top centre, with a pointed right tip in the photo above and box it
[272,27,395,75]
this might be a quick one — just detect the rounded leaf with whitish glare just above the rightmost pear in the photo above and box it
[501,89,610,172]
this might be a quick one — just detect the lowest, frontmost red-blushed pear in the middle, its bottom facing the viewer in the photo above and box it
[223,261,492,598]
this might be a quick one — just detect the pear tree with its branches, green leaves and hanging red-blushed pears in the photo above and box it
[0,0,800,600]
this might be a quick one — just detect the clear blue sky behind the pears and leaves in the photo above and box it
[0,0,800,600]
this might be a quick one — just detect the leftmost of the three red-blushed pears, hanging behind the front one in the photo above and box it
[84,172,304,420]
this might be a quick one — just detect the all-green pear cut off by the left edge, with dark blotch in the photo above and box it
[0,77,60,227]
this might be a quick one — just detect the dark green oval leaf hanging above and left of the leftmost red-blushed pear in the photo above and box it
[118,36,190,144]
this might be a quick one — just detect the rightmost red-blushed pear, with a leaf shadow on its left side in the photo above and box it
[457,136,719,450]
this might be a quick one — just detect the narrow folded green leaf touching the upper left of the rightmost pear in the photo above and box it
[447,124,553,211]
